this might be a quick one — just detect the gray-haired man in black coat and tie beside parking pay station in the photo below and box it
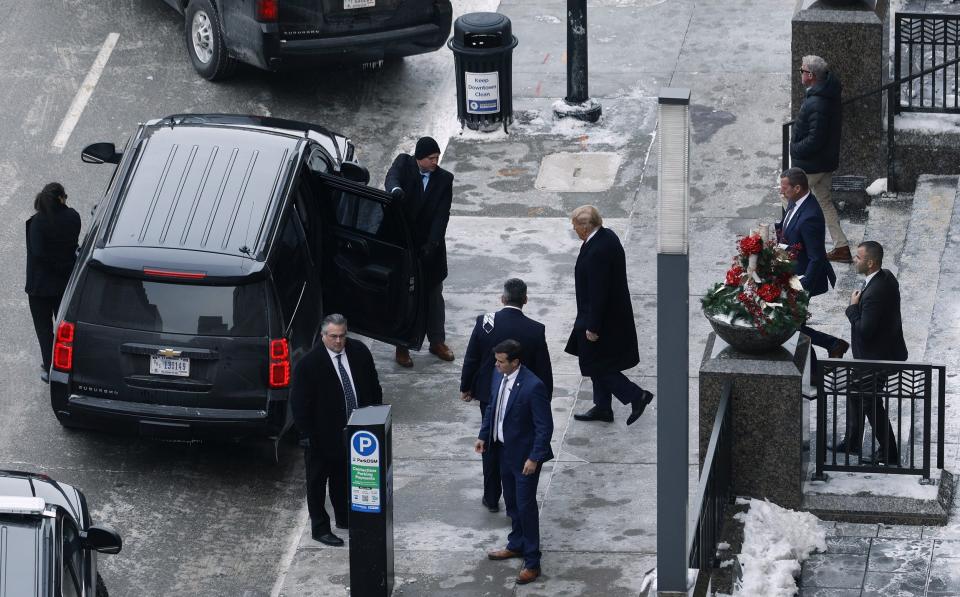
[290,313,383,545]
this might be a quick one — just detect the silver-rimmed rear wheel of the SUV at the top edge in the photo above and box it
[183,0,237,81]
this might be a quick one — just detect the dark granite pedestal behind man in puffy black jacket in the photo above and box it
[790,0,890,183]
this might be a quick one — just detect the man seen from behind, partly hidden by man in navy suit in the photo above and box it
[460,278,553,512]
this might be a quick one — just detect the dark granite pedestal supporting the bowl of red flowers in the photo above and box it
[700,333,810,509]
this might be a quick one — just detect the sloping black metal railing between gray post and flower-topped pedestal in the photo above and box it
[687,381,733,571]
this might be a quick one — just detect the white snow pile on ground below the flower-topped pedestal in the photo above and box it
[733,498,827,597]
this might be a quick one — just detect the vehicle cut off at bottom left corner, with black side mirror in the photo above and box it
[0,470,123,597]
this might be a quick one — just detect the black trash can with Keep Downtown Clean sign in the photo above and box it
[447,12,517,131]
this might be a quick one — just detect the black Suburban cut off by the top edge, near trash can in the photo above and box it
[166,0,453,81]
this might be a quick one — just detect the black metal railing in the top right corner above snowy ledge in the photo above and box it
[893,12,960,114]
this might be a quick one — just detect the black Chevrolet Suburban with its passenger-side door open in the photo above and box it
[50,115,425,440]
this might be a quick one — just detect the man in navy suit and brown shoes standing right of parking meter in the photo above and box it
[474,340,553,585]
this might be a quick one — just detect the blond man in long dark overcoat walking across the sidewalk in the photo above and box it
[565,205,653,425]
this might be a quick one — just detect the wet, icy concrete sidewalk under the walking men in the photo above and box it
[275,0,956,597]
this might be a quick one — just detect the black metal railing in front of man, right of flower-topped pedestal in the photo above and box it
[814,359,946,479]
